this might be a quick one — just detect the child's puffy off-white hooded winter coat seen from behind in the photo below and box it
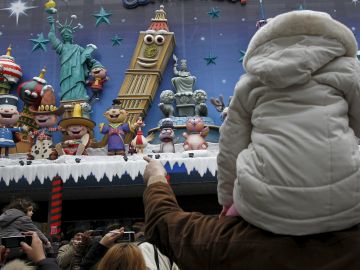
[218,11,360,235]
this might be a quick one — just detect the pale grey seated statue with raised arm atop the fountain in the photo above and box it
[171,54,196,93]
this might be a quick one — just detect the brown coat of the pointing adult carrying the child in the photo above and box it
[144,178,360,270]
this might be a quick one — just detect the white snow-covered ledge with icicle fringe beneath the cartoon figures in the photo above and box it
[0,143,218,185]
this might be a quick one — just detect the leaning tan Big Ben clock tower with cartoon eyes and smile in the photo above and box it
[117,5,175,138]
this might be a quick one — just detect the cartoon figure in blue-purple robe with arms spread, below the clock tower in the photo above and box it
[100,99,136,156]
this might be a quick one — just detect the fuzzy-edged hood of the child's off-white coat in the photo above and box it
[244,10,357,88]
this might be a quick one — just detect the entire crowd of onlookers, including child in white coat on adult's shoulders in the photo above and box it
[0,10,360,270]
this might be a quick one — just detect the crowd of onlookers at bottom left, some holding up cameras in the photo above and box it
[0,198,178,270]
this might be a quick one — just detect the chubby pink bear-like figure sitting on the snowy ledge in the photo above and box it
[183,116,209,151]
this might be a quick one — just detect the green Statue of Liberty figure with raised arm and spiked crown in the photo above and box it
[48,15,96,101]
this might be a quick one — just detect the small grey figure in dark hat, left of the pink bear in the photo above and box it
[153,119,175,153]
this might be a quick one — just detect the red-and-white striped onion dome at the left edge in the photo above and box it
[0,46,22,94]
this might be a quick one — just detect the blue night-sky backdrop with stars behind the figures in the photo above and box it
[0,0,360,142]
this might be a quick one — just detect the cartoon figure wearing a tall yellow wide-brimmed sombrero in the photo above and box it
[56,104,96,156]
